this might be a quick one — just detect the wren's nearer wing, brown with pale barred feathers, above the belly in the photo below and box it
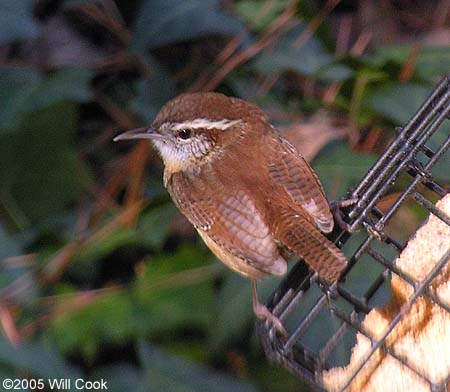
[168,173,287,275]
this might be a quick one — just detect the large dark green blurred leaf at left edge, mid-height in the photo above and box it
[0,104,89,224]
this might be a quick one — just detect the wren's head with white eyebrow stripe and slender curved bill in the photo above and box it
[114,93,268,170]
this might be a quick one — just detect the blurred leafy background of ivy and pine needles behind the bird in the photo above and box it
[0,0,450,391]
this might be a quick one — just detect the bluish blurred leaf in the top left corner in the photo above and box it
[0,0,39,42]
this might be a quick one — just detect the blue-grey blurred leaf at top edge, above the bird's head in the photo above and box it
[131,0,243,52]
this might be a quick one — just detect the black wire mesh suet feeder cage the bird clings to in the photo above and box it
[257,76,450,391]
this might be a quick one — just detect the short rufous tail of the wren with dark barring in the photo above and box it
[276,215,347,282]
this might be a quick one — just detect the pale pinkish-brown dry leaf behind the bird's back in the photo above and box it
[280,110,350,161]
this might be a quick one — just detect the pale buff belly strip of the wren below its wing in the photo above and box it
[197,229,269,279]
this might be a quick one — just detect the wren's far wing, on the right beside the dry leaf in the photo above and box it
[269,137,334,233]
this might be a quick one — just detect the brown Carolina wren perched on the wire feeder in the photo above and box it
[114,93,347,332]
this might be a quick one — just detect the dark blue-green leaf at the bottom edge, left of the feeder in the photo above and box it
[138,342,257,392]
